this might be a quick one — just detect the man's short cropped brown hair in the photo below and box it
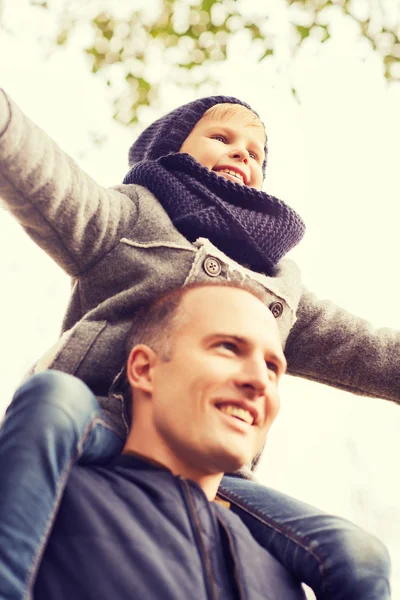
[126,281,263,360]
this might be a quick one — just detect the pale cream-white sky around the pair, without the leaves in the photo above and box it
[0,2,400,600]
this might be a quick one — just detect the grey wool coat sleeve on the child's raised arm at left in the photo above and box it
[0,90,137,276]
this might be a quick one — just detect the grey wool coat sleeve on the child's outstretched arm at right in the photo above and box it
[285,290,400,403]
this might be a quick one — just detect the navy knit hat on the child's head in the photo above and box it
[129,96,267,175]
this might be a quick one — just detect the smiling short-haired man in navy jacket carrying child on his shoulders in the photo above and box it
[34,284,304,600]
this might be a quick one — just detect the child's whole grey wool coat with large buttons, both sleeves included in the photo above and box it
[0,92,400,435]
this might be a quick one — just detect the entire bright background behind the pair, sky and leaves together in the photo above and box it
[0,0,400,600]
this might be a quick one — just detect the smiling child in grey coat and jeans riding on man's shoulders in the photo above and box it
[0,93,394,600]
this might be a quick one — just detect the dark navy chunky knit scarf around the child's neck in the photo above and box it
[124,153,305,275]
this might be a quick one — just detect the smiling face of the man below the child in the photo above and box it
[144,287,286,473]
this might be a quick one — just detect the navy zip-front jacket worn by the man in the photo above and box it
[34,455,304,600]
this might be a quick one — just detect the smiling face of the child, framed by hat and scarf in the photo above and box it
[180,109,265,190]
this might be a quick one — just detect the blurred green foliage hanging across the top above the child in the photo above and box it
[17,0,400,123]
